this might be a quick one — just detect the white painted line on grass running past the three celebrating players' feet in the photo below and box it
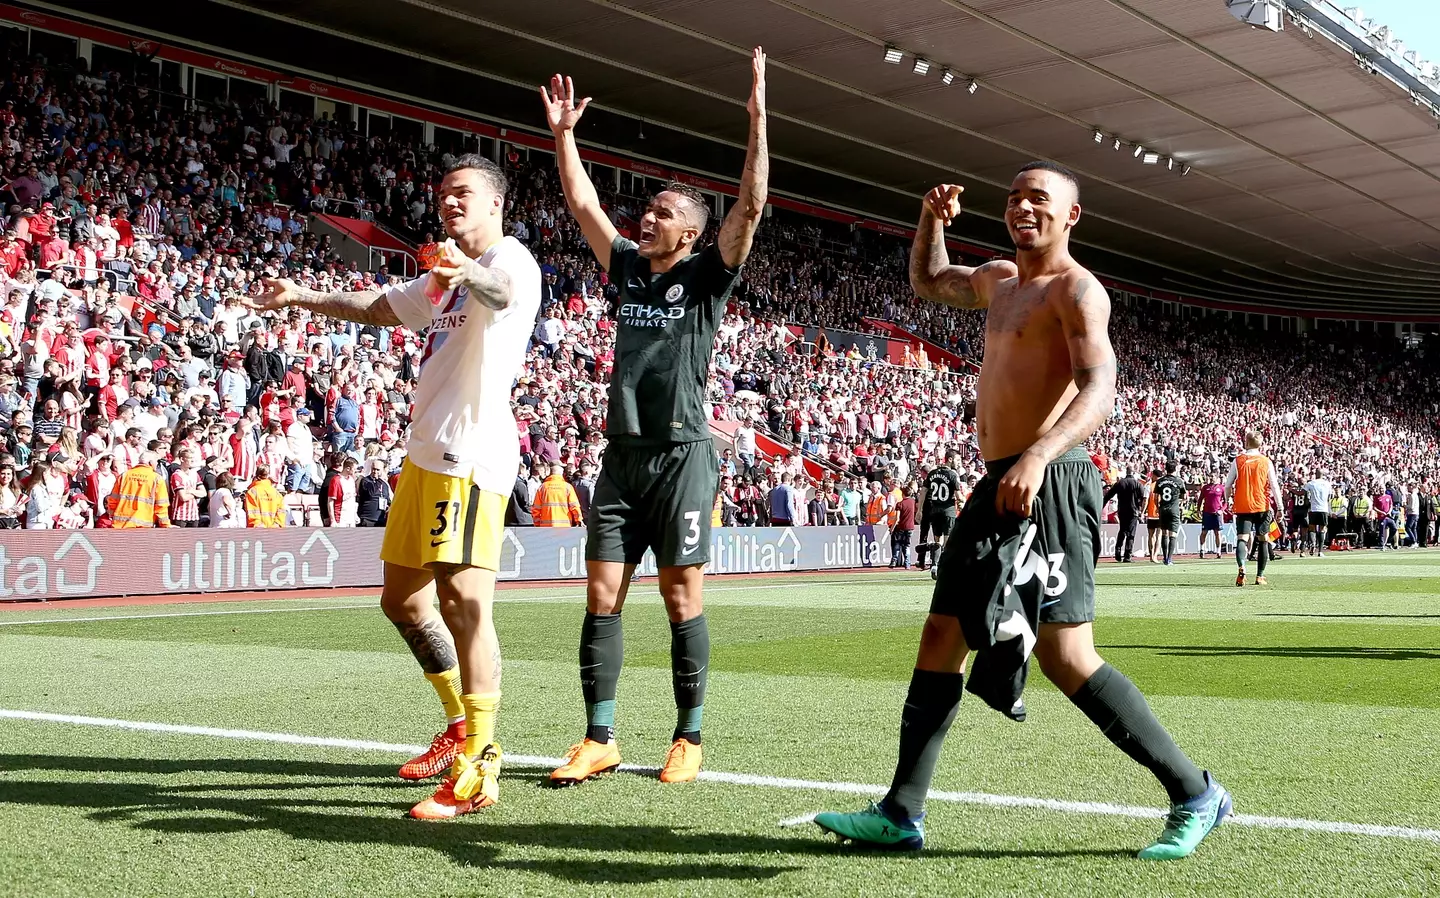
[0,708,1440,843]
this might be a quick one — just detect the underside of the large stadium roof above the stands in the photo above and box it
[56,0,1440,318]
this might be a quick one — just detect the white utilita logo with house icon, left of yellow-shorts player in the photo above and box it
[160,530,340,591]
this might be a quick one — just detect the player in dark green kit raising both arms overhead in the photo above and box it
[540,47,770,786]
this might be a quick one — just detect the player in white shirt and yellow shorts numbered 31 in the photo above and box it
[249,155,540,819]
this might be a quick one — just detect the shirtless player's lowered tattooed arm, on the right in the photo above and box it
[1028,275,1115,463]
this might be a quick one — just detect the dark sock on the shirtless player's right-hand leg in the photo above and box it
[1070,665,1207,803]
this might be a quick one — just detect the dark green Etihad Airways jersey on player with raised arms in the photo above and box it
[605,236,740,445]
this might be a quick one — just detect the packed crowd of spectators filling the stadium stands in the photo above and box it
[0,45,1440,555]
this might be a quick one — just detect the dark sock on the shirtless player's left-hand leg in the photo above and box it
[881,669,965,820]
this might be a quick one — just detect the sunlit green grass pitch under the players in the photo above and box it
[0,551,1440,898]
